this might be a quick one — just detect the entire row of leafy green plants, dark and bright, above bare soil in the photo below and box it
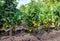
[0,0,60,32]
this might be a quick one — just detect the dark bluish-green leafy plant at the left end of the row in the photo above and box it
[0,0,22,28]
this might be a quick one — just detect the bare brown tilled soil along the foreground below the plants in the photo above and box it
[0,31,60,41]
